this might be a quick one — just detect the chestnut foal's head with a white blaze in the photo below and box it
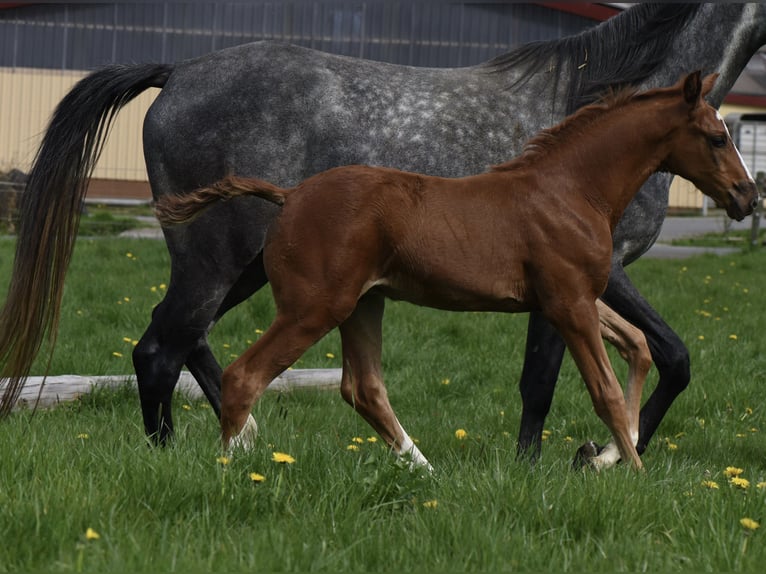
[663,72,758,221]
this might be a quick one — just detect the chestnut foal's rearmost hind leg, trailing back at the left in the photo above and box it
[221,310,337,448]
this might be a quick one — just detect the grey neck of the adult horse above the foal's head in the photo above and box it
[656,2,766,108]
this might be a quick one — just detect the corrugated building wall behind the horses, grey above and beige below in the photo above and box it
[0,0,594,184]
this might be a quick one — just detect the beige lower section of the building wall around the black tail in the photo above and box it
[0,68,159,181]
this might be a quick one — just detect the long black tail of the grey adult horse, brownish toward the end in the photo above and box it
[0,64,173,416]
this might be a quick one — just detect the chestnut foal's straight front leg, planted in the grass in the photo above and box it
[553,299,643,469]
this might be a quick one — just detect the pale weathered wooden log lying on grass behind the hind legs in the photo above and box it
[9,369,341,414]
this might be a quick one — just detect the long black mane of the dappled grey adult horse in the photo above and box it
[483,3,700,115]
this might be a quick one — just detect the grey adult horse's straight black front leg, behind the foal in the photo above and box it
[516,312,566,462]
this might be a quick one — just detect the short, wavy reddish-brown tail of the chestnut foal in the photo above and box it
[154,175,289,225]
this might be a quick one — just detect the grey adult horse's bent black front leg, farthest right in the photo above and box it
[602,265,691,453]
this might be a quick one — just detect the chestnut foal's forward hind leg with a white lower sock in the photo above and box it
[339,293,433,471]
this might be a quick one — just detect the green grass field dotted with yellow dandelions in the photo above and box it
[0,239,766,572]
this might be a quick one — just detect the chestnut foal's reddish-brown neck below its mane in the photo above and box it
[551,100,677,230]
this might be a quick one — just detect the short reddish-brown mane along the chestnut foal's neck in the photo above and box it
[490,86,652,172]
